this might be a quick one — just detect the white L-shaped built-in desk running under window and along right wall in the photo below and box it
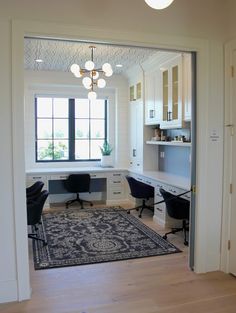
[26,167,191,227]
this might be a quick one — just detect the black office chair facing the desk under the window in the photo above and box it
[65,174,93,209]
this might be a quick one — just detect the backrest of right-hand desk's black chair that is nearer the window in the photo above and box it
[126,176,154,199]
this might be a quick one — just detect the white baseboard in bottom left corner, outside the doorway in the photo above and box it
[0,280,18,303]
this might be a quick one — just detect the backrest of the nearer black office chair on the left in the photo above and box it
[27,190,48,225]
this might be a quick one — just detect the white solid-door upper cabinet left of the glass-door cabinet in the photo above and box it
[145,68,162,125]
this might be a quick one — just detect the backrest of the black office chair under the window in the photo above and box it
[65,174,91,193]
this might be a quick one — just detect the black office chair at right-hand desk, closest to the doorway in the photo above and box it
[160,188,190,246]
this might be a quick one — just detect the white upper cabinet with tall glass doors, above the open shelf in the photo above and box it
[160,55,183,129]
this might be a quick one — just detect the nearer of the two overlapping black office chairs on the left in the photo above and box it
[27,190,48,246]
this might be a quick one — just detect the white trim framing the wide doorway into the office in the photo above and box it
[12,20,220,300]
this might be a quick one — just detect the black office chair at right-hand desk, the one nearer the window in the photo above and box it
[126,176,154,218]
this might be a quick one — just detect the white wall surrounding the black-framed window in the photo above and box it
[24,71,128,170]
